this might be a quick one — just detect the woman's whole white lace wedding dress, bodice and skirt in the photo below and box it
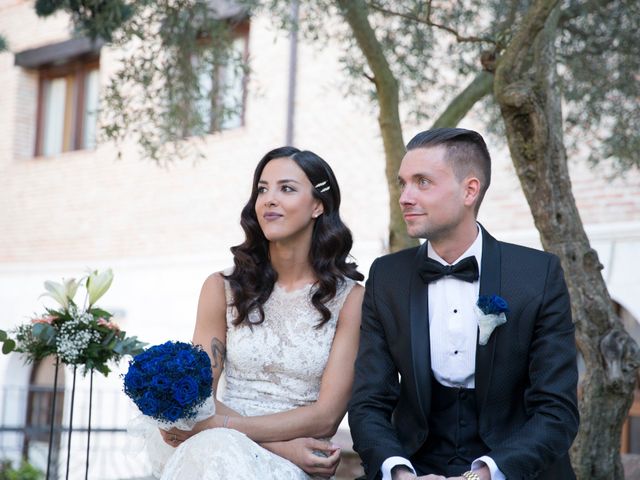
[161,279,355,480]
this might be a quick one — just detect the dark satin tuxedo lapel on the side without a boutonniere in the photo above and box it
[409,242,431,421]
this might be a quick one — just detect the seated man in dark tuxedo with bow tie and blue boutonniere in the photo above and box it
[349,128,578,480]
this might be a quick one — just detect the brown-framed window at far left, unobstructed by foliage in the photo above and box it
[36,57,99,156]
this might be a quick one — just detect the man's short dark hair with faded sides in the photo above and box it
[407,128,491,215]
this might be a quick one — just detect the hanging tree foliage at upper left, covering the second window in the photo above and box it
[36,0,247,163]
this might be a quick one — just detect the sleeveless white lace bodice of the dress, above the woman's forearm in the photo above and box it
[218,278,355,415]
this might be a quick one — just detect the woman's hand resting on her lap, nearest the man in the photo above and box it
[282,438,340,477]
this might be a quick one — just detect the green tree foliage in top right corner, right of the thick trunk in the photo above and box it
[557,0,640,172]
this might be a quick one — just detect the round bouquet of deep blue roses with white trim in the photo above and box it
[124,342,214,430]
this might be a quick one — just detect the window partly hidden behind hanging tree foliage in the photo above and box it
[190,22,249,135]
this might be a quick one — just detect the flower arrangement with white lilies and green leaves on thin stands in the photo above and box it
[0,269,145,376]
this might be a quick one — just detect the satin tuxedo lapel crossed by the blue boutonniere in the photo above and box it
[475,227,501,412]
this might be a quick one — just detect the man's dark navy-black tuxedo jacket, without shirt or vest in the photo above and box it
[349,229,578,480]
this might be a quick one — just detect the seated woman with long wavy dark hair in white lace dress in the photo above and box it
[161,147,364,480]
